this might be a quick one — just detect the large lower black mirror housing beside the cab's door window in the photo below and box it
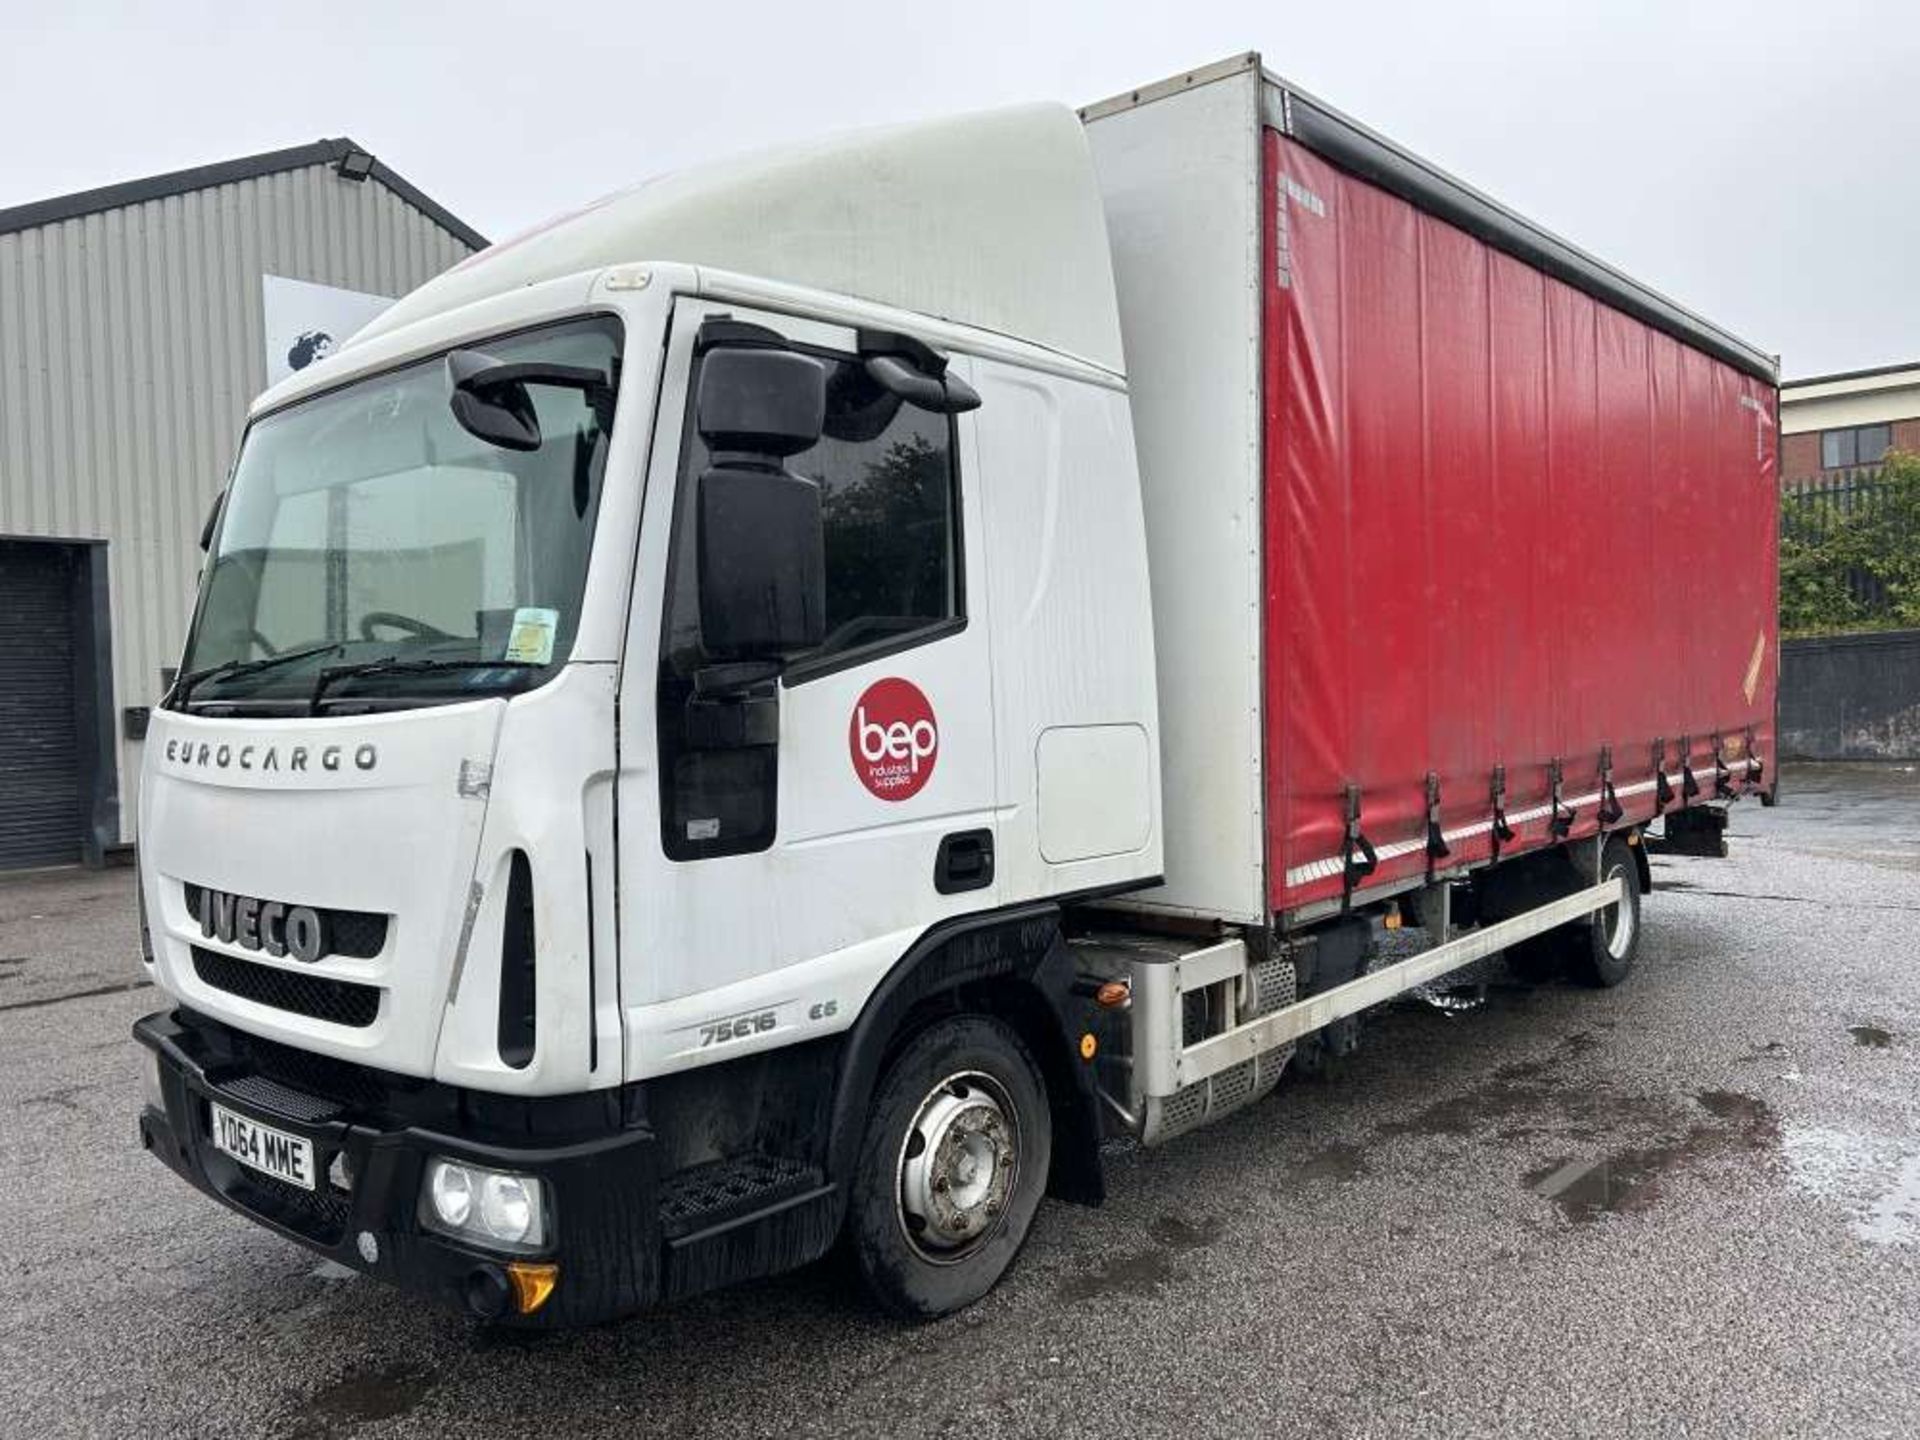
[697,467,828,660]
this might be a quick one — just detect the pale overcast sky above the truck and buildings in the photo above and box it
[0,0,1920,376]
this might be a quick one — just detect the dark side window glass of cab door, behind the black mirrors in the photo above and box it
[657,337,966,860]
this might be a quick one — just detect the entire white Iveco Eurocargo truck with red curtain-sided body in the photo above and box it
[134,56,1778,1325]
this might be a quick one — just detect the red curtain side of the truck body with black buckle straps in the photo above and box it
[1263,131,1778,910]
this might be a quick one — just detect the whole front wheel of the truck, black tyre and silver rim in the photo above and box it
[847,1016,1052,1319]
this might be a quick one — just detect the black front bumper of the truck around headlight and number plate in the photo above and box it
[132,1014,662,1329]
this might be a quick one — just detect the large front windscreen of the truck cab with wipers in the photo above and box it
[175,317,620,712]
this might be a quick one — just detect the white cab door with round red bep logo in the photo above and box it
[618,300,998,1077]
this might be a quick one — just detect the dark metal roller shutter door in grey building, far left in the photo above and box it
[0,540,81,870]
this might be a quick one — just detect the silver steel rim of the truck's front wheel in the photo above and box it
[893,1069,1020,1265]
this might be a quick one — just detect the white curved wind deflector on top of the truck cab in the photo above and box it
[344,104,1125,372]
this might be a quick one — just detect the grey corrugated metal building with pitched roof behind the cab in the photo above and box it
[0,140,486,870]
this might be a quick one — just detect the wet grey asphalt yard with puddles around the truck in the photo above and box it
[0,766,1920,1438]
